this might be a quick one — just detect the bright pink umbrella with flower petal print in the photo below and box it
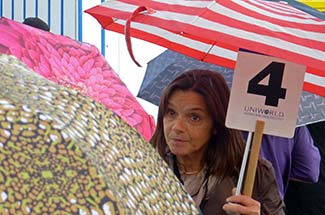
[0,18,155,140]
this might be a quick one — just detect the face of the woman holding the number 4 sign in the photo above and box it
[163,90,213,159]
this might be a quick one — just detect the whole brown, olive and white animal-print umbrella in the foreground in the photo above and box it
[0,54,198,215]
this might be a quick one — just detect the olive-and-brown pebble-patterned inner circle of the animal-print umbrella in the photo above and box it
[0,100,123,214]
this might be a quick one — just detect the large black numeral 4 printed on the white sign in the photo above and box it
[247,62,287,107]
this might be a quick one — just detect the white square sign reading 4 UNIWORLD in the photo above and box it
[226,51,306,138]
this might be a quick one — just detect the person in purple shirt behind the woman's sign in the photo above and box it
[243,126,320,199]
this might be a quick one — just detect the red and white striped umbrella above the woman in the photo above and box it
[86,0,325,96]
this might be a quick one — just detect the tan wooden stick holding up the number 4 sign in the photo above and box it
[242,120,265,197]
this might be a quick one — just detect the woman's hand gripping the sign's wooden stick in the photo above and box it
[222,188,261,215]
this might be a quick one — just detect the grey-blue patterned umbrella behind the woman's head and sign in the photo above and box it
[138,50,325,126]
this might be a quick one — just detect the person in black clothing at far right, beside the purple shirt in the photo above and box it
[284,121,325,215]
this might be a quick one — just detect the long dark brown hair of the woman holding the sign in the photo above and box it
[150,70,245,179]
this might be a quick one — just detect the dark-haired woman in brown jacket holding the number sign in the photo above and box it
[150,70,284,215]
